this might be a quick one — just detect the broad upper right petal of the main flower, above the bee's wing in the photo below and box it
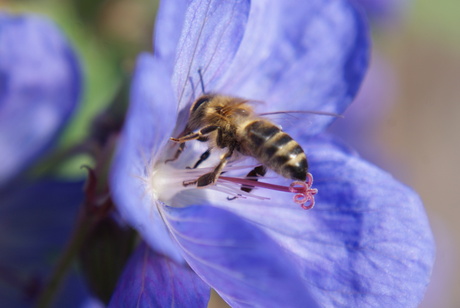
[216,0,369,134]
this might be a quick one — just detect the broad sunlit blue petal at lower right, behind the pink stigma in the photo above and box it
[210,138,435,307]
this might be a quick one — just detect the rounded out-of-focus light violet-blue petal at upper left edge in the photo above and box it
[0,13,81,185]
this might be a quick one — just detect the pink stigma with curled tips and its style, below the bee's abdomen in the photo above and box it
[219,173,318,210]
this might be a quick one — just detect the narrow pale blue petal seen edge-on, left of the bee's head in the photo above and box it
[111,54,182,260]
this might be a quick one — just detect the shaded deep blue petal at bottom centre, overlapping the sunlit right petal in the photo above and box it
[166,206,316,307]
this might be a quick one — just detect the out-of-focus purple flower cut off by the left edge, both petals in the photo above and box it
[0,13,89,307]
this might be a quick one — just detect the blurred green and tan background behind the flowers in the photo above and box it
[0,0,460,308]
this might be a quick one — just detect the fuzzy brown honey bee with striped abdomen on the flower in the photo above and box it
[166,94,308,191]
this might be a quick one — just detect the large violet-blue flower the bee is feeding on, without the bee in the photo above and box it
[111,0,434,307]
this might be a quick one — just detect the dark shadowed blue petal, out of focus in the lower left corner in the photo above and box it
[0,181,89,307]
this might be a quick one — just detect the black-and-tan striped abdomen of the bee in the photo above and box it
[241,120,308,181]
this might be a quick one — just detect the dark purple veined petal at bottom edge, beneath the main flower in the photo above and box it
[109,245,210,308]
